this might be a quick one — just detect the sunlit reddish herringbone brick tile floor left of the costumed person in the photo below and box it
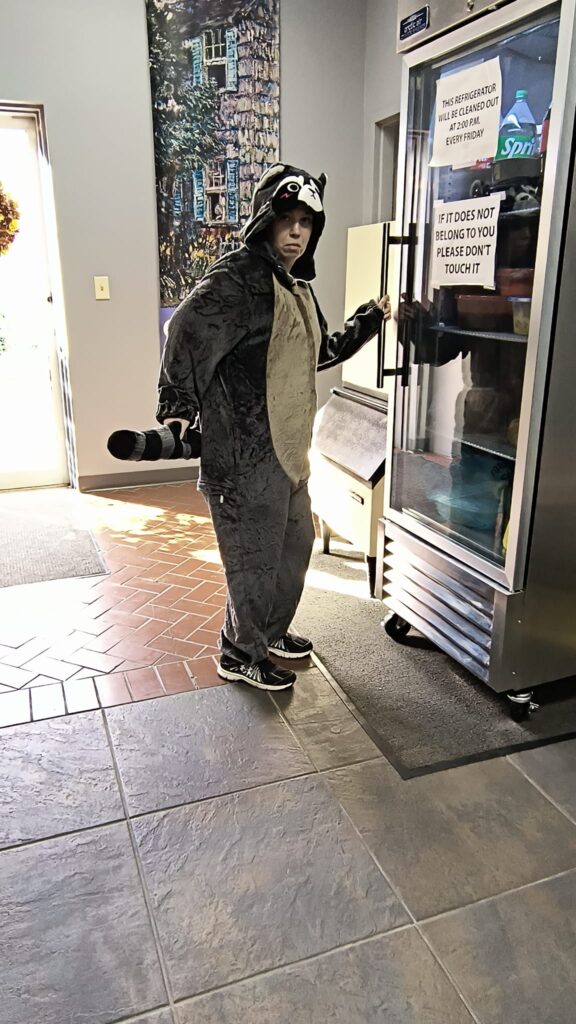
[0,481,233,727]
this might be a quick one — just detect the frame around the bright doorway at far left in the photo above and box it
[0,99,78,489]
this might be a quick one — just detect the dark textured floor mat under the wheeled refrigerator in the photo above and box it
[295,544,576,778]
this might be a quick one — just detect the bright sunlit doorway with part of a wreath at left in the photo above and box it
[0,105,70,490]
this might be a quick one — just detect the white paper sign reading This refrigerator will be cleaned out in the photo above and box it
[430,57,502,167]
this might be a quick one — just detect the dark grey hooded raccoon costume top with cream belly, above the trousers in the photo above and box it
[157,164,383,492]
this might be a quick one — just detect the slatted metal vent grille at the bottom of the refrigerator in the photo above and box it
[384,539,494,682]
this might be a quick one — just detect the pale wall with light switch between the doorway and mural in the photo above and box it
[0,0,159,485]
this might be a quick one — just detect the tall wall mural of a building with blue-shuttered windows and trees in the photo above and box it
[147,0,280,322]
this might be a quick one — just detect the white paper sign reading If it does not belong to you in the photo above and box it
[430,193,505,288]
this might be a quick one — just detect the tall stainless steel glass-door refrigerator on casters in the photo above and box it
[379,0,576,718]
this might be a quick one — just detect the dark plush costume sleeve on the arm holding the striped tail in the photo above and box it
[156,266,250,423]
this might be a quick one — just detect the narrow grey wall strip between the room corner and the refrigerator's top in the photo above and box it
[363,0,403,223]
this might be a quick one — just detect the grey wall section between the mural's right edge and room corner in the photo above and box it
[280,0,371,401]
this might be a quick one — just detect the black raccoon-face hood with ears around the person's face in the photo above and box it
[242,164,326,281]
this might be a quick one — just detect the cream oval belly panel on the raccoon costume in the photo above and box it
[266,278,322,483]
